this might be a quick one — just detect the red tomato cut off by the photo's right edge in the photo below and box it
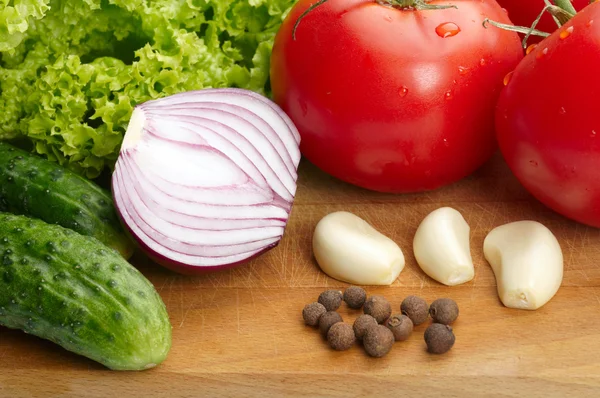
[496,3,600,227]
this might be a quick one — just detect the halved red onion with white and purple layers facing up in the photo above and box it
[112,89,300,273]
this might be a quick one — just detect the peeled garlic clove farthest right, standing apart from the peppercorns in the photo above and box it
[483,221,563,310]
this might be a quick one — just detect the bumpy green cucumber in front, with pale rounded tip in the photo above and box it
[0,213,171,370]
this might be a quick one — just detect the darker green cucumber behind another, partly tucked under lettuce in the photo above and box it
[0,142,134,259]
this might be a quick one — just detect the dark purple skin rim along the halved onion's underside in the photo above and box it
[113,194,281,276]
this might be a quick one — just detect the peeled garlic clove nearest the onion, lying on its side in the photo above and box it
[313,211,404,285]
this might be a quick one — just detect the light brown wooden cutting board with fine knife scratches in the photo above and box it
[0,156,600,398]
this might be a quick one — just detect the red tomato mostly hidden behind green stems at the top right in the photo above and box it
[497,0,590,43]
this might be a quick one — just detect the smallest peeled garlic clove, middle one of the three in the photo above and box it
[413,207,475,286]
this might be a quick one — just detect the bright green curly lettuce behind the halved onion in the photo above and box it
[0,0,296,178]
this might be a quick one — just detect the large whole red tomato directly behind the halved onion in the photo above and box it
[271,0,523,192]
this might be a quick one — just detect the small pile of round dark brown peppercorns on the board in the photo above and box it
[302,286,458,358]
